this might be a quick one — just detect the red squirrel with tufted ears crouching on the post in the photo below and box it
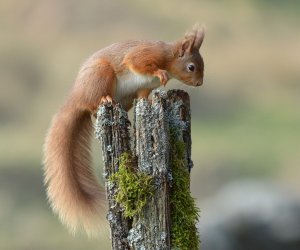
[44,25,204,236]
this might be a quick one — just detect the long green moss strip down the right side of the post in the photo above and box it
[170,131,200,250]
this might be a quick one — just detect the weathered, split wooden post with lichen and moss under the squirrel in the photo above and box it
[96,90,199,250]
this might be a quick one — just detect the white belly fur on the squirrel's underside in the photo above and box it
[115,71,160,101]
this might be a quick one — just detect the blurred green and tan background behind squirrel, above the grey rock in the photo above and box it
[0,0,300,250]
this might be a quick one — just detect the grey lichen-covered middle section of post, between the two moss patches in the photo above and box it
[129,92,171,250]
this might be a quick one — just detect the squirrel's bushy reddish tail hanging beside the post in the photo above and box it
[44,102,105,236]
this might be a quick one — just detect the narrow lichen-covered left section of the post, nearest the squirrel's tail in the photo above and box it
[95,104,130,250]
